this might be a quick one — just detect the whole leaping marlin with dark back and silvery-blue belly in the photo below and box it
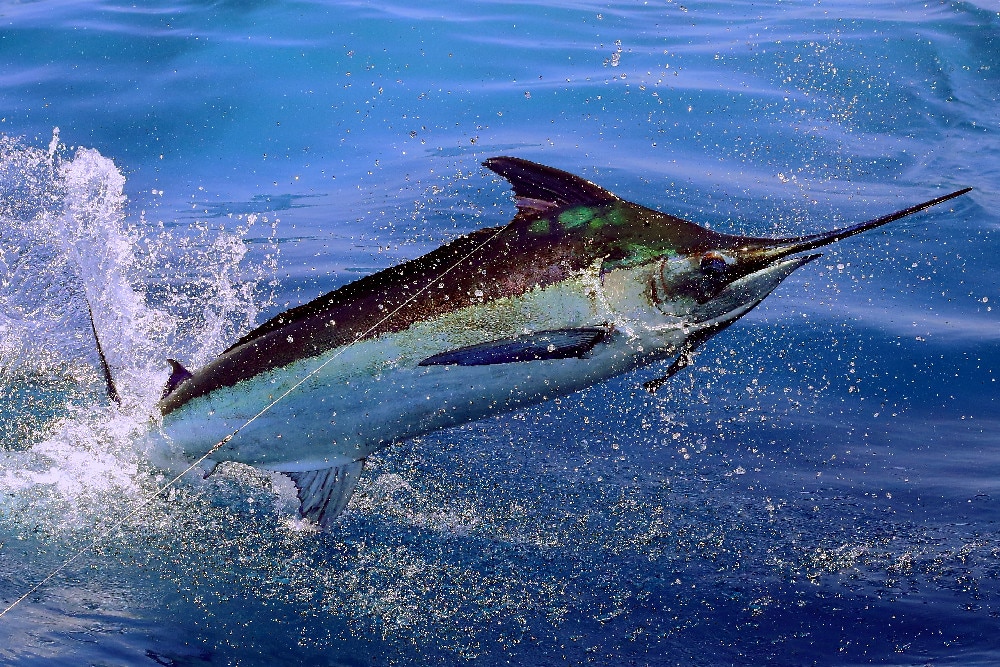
[113,157,971,528]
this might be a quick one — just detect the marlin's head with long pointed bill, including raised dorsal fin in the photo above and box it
[485,157,971,345]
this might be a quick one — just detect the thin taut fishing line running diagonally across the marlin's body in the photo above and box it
[0,219,510,618]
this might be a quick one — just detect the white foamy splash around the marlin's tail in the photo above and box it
[0,129,273,533]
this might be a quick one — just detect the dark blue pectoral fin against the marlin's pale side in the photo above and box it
[419,327,608,366]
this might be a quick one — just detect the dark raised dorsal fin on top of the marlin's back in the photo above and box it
[483,157,621,215]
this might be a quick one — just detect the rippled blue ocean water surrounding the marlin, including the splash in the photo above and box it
[0,0,1000,665]
